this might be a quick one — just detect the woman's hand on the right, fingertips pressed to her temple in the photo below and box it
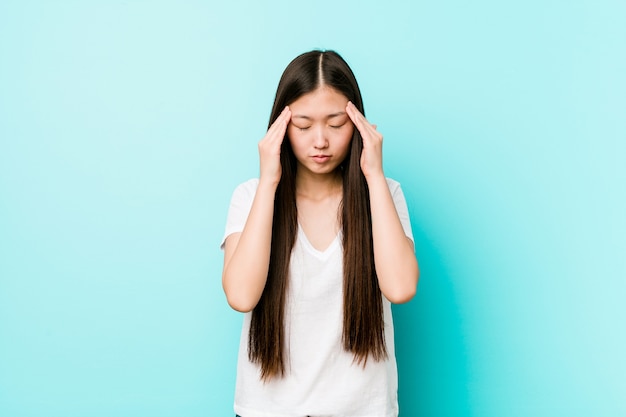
[346,101,384,180]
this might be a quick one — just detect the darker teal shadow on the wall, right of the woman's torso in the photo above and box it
[393,226,471,417]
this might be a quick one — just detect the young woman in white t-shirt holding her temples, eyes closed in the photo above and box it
[222,51,419,417]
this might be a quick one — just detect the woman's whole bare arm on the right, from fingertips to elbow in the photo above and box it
[346,103,419,303]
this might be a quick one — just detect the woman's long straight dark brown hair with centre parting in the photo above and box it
[248,51,387,381]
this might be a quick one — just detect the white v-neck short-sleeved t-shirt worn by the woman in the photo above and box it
[222,179,413,417]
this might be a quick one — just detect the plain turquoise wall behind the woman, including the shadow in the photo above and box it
[0,0,626,417]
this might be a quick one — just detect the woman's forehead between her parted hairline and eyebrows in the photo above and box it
[289,86,348,118]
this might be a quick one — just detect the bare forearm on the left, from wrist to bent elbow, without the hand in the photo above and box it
[222,183,276,312]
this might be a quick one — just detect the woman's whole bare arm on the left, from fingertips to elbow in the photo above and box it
[222,108,291,312]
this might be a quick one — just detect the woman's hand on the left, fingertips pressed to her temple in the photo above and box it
[259,106,291,185]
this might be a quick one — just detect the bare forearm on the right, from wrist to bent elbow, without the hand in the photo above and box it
[368,176,419,303]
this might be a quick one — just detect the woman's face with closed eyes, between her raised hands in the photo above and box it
[287,86,354,174]
